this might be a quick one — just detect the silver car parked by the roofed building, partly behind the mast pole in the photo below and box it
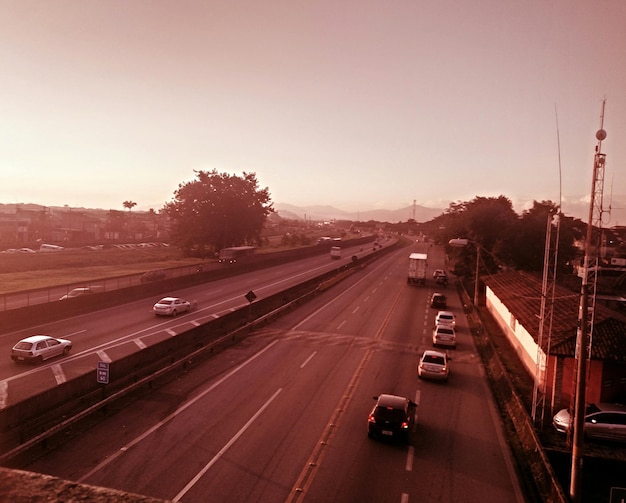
[552,403,626,442]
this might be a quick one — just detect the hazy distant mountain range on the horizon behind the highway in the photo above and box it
[274,203,444,223]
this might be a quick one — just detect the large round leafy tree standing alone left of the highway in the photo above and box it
[164,170,274,256]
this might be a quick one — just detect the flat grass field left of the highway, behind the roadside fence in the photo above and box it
[0,248,200,293]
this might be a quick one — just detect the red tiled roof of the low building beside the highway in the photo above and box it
[481,271,626,362]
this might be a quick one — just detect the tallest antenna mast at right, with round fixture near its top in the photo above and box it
[570,100,606,503]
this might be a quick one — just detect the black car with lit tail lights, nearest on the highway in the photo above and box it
[367,394,417,441]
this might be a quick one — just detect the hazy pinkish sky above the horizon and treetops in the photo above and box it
[0,0,626,225]
